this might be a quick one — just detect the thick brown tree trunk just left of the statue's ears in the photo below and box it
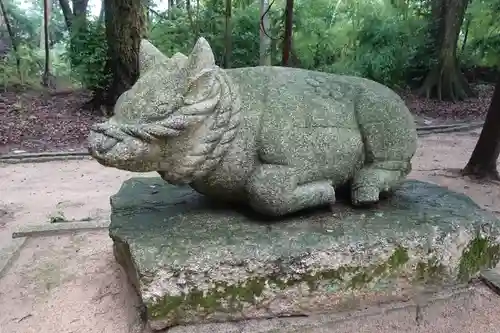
[93,0,145,113]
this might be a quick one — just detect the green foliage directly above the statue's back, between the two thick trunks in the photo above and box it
[150,0,438,86]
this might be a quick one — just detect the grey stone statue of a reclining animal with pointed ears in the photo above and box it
[89,38,417,216]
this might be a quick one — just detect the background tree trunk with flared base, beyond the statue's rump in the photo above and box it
[419,0,475,101]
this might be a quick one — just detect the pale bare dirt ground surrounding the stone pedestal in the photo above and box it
[0,131,500,333]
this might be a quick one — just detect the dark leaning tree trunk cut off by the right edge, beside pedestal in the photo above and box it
[462,77,500,180]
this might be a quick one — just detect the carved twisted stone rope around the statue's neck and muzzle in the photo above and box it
[94,66,241,182]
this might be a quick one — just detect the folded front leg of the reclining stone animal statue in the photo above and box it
[247,164,335,216]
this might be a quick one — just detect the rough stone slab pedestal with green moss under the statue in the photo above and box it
[110,178,500,329]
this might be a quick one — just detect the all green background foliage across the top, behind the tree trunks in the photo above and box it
[0,0,500,89]
